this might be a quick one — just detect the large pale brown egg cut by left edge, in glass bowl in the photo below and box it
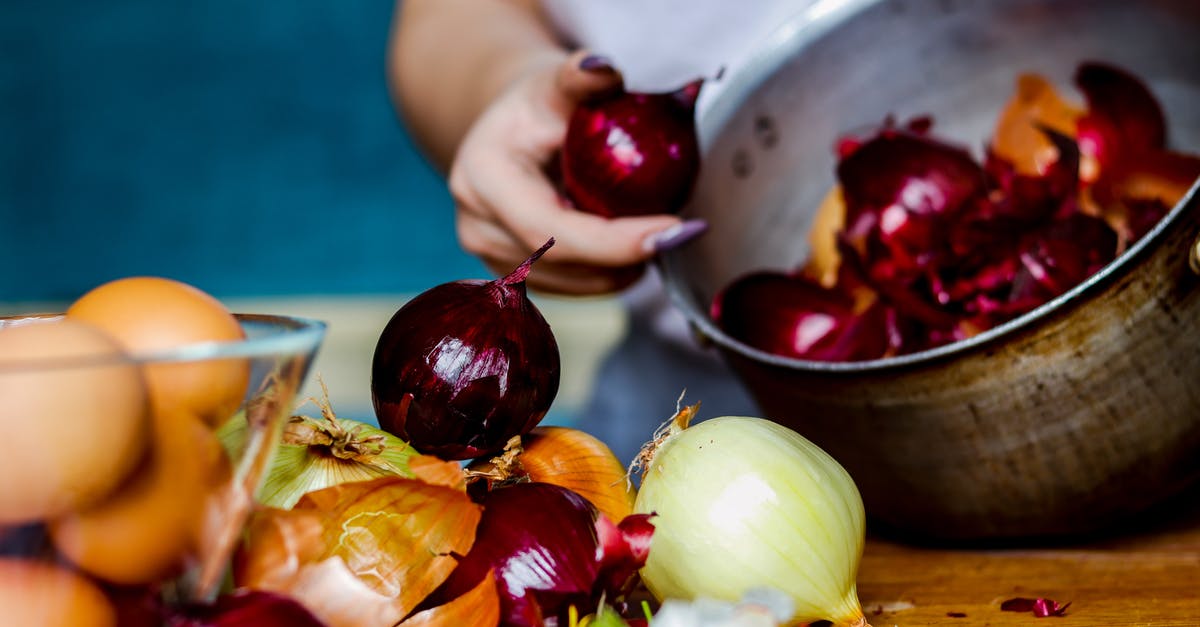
[0,318,149,525]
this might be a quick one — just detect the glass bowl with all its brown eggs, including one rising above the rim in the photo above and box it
[0,276,325,625]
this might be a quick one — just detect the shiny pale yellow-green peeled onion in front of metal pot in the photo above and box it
[635,417,866,626]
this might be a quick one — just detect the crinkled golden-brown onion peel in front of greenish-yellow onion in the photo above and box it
[234,477,480,627]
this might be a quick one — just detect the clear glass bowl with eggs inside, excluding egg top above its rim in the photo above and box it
[0,314,325,625]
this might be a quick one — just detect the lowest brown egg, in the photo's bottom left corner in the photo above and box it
[0,557,116,627]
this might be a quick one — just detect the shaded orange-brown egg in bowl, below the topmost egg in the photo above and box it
[49,413,229,585]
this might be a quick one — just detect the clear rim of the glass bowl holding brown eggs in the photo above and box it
[0,312,328,374]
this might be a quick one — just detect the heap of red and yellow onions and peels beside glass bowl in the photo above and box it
[208,240,653,627]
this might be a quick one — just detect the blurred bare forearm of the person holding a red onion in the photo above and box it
[388,0,566,171]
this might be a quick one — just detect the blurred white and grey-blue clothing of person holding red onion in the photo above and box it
[542,0,814,462]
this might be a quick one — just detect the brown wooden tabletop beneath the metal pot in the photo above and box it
[858,501,1200,627]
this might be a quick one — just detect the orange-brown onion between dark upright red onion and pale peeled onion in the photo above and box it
[468,426,636,523]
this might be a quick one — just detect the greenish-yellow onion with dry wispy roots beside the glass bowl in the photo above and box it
[218,382,418,509]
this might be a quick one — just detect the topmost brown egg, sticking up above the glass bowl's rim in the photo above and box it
[67,276,250,426]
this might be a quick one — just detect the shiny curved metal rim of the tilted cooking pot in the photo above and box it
[655,0,1200,374]
